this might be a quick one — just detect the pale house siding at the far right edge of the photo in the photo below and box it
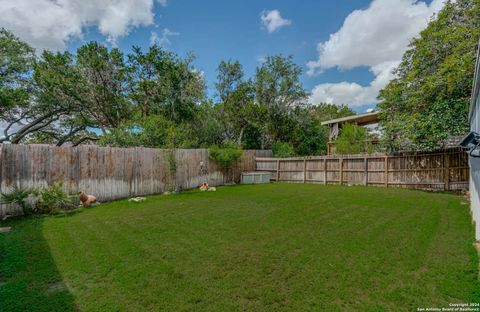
[470,90,480,240]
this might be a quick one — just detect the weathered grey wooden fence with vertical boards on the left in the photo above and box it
[0,144,272,217]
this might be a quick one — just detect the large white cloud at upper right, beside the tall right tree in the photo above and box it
[307,0,445,105]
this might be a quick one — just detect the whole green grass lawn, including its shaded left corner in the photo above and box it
[0,184,480,311]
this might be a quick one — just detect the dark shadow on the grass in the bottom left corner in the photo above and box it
[0,217,77,311]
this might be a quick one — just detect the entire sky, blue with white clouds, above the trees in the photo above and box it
[0,0,444,113]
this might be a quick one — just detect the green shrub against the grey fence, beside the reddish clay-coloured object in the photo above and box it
[36,182,78,214]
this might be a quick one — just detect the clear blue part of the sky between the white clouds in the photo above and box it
[110,0,373,102]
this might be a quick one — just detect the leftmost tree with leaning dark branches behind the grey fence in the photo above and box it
[0,33,94,144]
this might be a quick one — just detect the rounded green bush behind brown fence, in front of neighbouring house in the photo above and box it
[335,123,372,154]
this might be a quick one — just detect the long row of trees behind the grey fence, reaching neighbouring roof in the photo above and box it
[0,29,353,155]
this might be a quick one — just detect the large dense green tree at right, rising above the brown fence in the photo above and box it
[379,0,480,150]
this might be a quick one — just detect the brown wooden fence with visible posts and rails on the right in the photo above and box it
[256,149,469,191]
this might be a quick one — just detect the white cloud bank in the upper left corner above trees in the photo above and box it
[0,0,163,50]
